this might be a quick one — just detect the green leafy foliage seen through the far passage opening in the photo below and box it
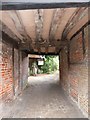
[40,55,59,73]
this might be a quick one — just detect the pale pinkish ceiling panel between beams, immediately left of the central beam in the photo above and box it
[18,10,36,43]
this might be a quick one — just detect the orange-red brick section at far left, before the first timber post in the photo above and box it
[0,43,13,99]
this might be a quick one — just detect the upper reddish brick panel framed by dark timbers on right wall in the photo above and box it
[70,32,83,63]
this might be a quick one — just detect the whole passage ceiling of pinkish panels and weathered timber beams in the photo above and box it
[0,8,88,54]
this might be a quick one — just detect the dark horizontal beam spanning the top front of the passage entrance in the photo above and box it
[0,0,90,10]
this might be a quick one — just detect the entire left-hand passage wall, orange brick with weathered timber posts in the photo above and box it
[0,40,28,101]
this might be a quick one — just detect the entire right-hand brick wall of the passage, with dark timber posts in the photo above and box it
[60,26,88,116]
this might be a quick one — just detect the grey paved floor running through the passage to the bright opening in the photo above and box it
[2,72,84,118]
